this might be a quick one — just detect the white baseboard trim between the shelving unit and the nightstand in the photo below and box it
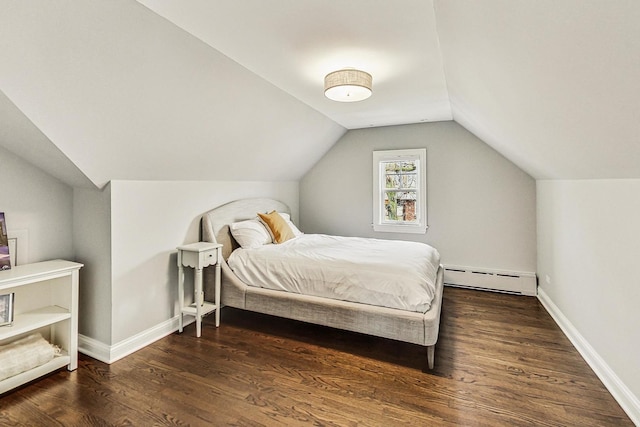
[78,316,194,364]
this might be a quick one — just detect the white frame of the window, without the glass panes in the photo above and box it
[373,148,428,234]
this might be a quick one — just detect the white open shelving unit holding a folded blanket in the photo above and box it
[0,260,83,394]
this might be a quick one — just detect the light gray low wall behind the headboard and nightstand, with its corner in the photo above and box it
[85,181,298,350]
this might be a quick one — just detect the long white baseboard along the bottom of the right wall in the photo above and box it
[538,288,640,426]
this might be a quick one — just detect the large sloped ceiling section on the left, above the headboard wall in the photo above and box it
[0,0,346,187]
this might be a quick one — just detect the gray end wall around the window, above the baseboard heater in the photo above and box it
[300,121,536,272]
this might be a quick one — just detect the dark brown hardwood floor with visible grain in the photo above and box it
[0,288,633,426]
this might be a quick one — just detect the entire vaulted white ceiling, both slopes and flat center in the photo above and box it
[0,0,640,187]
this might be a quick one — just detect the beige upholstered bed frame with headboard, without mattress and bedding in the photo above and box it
[201,198,443,369]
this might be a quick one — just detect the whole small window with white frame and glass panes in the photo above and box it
[373,148,427,233]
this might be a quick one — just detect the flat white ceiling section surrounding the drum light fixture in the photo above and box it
[139,0,452,129]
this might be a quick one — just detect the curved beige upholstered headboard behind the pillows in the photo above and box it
[200,198,291,260]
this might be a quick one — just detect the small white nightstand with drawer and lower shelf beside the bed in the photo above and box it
[177,242,222,337]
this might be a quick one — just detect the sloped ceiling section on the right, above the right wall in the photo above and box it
[436,0,640,179]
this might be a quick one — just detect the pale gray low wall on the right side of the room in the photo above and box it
[537,179,640,408]
